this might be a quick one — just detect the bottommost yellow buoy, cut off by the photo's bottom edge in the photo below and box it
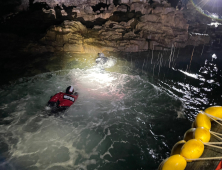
[158,154,187,170]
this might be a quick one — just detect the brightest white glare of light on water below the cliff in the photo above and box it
[70,68,126,99]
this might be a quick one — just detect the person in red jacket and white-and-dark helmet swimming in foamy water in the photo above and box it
[47,86,78,113]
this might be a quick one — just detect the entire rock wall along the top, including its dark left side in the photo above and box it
[0,0,221,53]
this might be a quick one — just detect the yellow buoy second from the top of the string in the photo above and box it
[195,113,211,130]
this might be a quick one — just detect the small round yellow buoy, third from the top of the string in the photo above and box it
[194,127,211,142]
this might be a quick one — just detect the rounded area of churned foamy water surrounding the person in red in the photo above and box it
[0,65,188,170]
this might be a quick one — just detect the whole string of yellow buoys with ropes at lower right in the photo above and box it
[158,106,222,170]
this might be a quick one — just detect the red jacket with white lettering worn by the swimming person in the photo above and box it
[49,92,78,107]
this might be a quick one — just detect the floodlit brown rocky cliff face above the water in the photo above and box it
[0,0,214,52]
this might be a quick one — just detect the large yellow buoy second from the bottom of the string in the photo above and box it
[180,139,204,162]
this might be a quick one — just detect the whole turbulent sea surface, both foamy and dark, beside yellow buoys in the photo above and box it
[0,49,222,170]
